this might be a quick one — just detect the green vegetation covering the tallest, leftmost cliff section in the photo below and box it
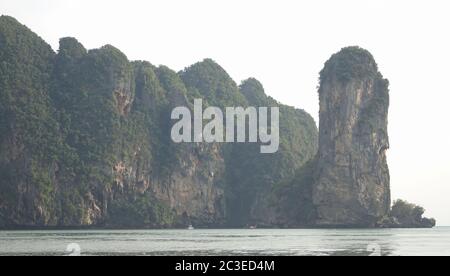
[0,16,61,225]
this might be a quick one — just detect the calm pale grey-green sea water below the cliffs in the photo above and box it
[0,227,450,256]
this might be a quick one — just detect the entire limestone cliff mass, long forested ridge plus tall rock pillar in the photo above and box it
[0,16,435,228]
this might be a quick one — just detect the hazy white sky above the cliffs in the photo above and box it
[0,0,450,225]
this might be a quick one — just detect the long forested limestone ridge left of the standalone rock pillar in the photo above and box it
[0,16,318,227]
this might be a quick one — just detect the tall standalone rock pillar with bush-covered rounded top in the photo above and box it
[313,47,390,227]
